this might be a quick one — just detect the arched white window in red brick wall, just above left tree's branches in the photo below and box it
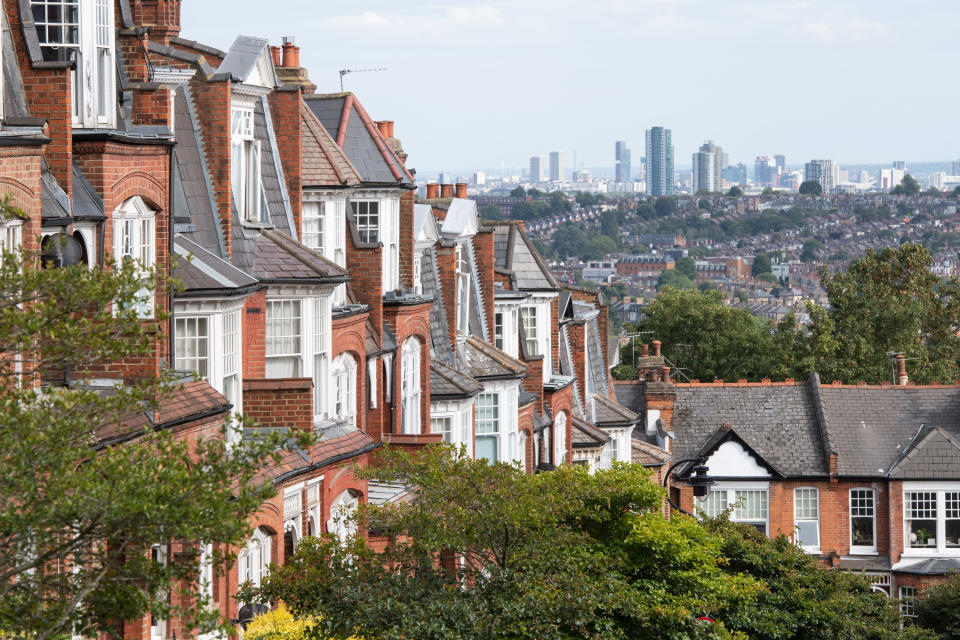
[113,196,157,318]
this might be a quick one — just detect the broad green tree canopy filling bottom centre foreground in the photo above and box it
[251,447,929,640]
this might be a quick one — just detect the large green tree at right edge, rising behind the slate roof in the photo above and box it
[805,243,960,384]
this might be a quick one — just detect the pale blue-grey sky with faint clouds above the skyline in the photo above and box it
[182,0,960,177]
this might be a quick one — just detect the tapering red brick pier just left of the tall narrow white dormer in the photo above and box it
[191,79,233,259]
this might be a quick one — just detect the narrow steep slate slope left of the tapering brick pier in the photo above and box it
[174,86,226,258]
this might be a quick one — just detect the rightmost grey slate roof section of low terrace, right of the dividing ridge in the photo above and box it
[818,381,960,477]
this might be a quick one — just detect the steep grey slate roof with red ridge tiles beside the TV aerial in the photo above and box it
[304,93,413,188]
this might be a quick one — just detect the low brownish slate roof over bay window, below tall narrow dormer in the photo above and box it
[253,229,347,282]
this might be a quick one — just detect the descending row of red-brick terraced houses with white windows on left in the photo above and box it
[0,0,644,640]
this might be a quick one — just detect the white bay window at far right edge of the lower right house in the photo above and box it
[903,485,960,555]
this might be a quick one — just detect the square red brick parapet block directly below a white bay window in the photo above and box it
[243,378,313,431]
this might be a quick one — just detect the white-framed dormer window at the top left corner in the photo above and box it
[30,0,117,128]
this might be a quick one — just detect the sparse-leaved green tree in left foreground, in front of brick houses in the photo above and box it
[0,231,305,640]
